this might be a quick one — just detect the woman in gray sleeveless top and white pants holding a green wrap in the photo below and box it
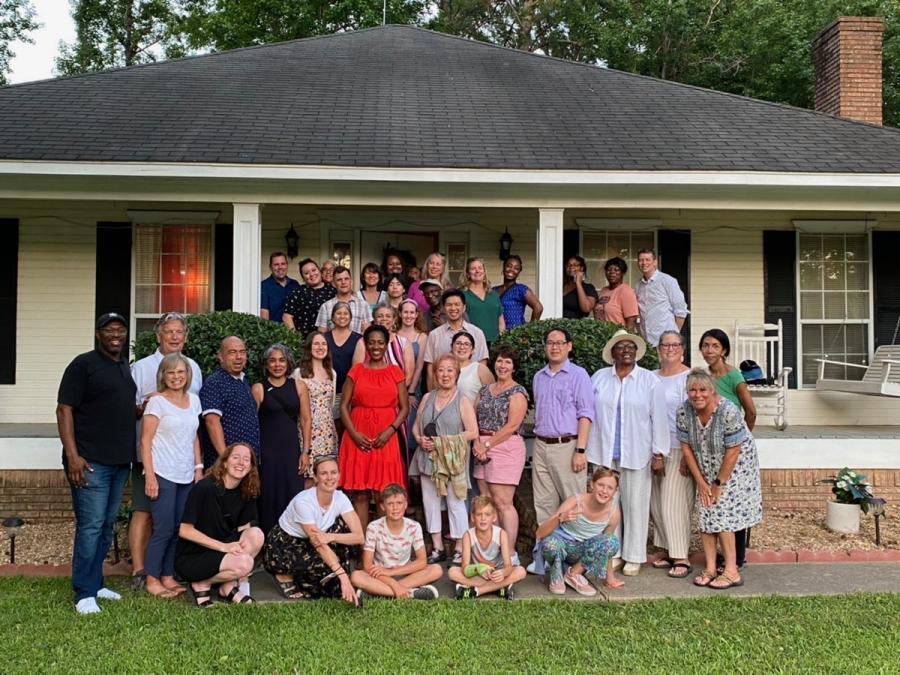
[413,354,478,565]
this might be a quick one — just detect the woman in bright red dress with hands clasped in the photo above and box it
[338,325,409,531]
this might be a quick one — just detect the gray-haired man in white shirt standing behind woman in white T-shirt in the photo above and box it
[128,312,203,590]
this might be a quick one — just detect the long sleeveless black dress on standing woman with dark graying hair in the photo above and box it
[259,378,303,532]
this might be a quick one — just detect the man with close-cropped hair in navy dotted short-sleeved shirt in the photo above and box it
[200,335,259,468]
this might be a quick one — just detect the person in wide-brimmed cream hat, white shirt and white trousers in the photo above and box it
[587,330,669,577]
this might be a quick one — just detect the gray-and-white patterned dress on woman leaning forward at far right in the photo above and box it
[676,398,762,533]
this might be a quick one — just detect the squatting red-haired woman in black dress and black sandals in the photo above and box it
[175,443,263,607]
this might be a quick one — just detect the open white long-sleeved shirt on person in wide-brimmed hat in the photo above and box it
[587,366,669,469]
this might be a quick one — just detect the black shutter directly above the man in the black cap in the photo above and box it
[94,223,132,321]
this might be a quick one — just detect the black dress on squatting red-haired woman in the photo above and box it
[175,476,256,581]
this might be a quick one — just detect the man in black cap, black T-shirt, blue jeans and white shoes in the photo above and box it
[56,313,136,614]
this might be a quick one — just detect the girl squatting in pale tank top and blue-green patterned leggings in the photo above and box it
[535,467,624,596]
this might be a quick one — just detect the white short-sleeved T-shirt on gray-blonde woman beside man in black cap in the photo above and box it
[144,393,200,485]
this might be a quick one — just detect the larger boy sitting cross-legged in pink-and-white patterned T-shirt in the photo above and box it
[350,483,444,600]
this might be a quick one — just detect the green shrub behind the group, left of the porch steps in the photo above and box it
[134,311,303,382]
